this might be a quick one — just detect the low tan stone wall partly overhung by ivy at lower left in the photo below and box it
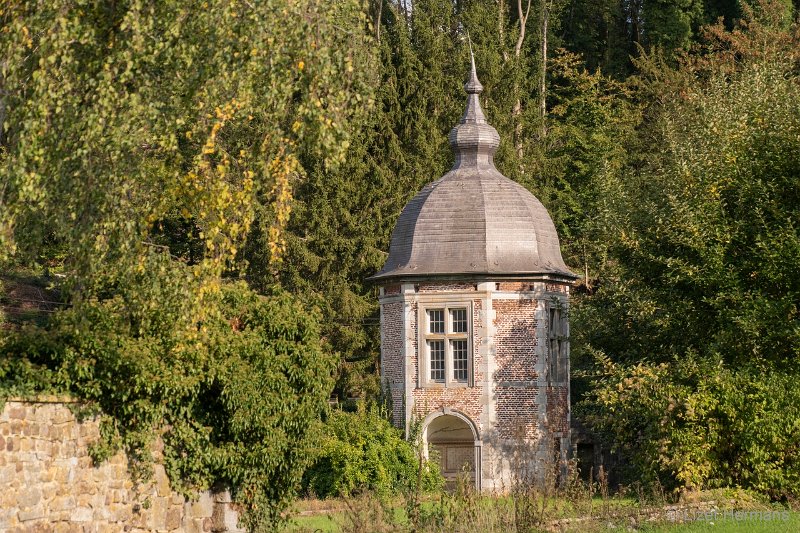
[0,398,243,533]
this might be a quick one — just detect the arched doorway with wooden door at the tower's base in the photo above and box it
[423,409,480,488]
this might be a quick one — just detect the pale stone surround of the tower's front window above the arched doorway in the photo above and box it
[417,293,475,389]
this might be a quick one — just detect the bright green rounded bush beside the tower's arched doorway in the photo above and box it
[303,403,442,498]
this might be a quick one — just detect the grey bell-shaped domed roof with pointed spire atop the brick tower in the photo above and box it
[370,51,577,281]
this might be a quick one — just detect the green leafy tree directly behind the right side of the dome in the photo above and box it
[529,50,641,287]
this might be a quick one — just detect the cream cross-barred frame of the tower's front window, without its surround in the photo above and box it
[418,301,474,388]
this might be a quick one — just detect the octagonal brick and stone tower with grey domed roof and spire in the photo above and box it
[370,52,577,490]
